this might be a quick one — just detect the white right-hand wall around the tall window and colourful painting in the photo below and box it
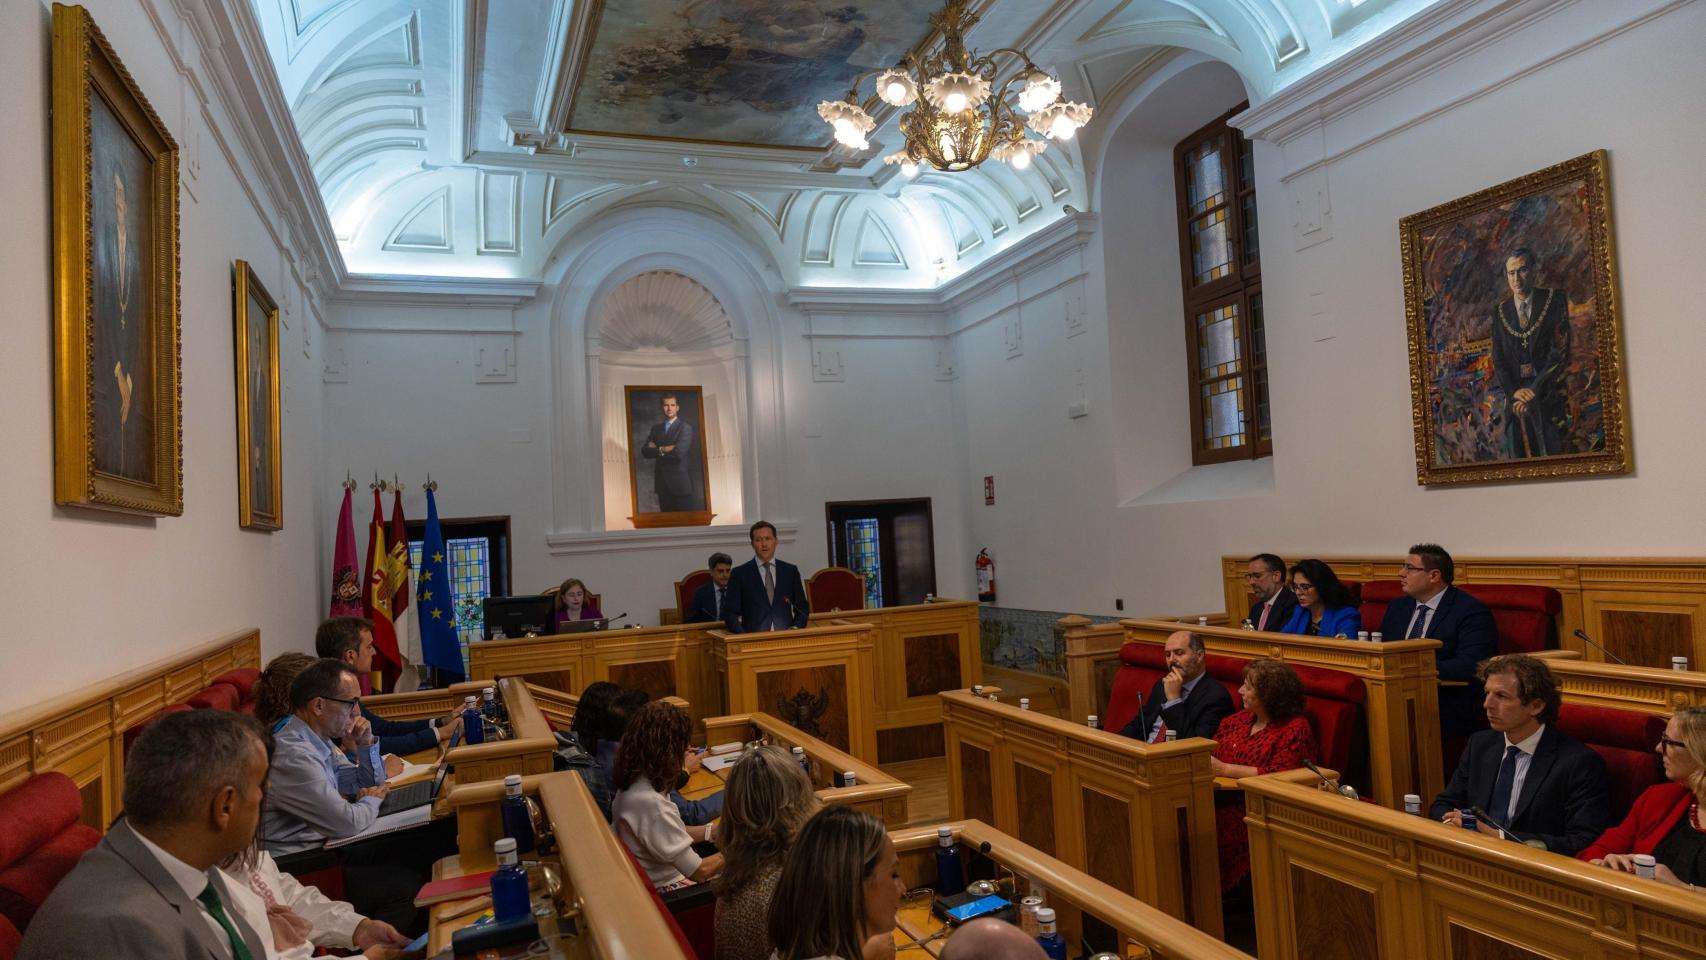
[960,2,1706,614]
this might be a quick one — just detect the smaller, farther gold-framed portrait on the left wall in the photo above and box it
[232,259,285,530]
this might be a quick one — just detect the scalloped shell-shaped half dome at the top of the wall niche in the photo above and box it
[597,269,734,353]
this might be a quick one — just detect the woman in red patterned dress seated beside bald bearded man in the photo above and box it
[1208,660,1315,892]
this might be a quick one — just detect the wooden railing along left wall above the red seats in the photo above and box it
[0,627,261,830]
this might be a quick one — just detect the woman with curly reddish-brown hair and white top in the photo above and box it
[611,701,723,892]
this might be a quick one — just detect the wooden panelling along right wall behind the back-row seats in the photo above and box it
[1220,554,1706,667]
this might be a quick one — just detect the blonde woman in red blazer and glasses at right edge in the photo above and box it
[1576,706,1706,892]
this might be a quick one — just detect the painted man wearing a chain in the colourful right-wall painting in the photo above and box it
[1493,247,1570,459]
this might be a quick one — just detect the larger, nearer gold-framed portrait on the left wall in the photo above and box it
[53,3,184,517]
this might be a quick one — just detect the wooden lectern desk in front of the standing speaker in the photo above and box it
[711,621,877,764]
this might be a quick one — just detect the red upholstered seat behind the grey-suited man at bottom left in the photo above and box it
[0,772,101,957]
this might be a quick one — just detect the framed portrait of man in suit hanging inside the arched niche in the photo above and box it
[624,387,711,529]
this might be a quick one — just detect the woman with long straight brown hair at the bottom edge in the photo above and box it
[769,807,906,960]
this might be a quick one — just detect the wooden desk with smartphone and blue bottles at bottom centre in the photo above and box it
[889,820,1250,960]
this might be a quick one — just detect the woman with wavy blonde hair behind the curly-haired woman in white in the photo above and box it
[717,747,817,960]
